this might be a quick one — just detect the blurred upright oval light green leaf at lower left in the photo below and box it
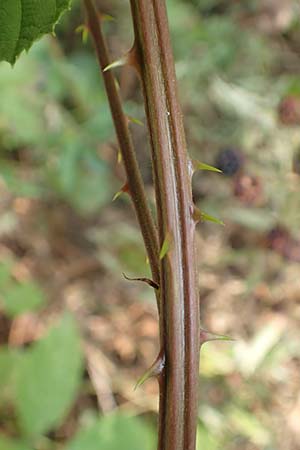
[16,314,82,436]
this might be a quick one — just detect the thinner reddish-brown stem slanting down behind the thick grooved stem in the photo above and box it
[84,0,159,283]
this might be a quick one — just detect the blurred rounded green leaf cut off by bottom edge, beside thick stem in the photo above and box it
[66,413,155,450]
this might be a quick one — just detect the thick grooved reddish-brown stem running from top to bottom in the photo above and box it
[131,0,200,450]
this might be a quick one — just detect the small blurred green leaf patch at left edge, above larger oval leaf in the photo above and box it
[1,281,45,317]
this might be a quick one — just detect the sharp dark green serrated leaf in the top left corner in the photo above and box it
[0,0,71,64]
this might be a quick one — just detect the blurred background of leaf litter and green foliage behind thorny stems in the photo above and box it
[0,0,300,450]
